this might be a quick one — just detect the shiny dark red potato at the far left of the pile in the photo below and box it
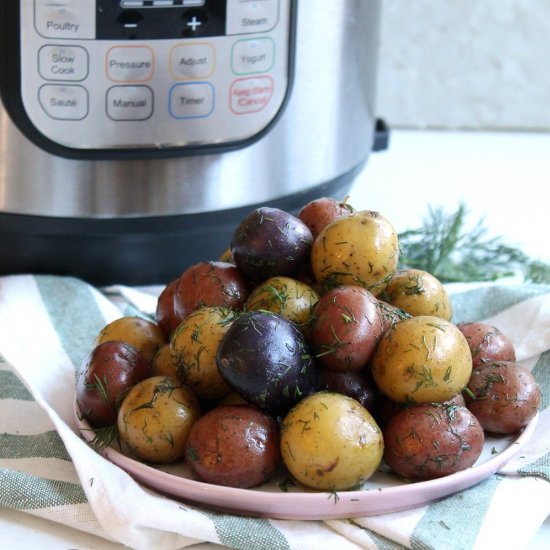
[76,341,151,428]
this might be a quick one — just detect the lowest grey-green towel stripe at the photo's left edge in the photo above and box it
[0,468,88,510]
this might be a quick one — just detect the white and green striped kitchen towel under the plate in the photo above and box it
[0,275,550,550]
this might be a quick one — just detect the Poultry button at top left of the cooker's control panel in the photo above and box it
[34,0,95,39]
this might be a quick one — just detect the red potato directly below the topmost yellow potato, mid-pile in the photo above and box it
[309,285,382,371]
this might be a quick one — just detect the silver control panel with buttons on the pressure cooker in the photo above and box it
[16,0,292,155]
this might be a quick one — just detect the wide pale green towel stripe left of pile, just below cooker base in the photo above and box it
[35,275,110,368]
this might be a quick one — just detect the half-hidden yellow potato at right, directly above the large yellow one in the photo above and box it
[384,269,453,321]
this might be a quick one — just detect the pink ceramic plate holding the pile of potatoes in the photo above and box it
[75,408,538,520]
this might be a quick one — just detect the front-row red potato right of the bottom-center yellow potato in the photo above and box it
[383,403,485,481]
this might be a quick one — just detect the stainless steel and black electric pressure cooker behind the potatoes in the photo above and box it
[0,0,387,285]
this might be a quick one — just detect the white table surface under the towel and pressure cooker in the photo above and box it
[0,131,550,550]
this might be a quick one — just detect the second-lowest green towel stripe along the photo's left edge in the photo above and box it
[0,431,70,461]
